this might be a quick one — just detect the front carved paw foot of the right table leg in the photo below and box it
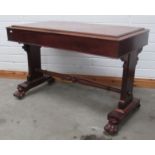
[104,122,118,135]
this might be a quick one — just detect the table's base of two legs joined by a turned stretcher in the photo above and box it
[14,45,141,135]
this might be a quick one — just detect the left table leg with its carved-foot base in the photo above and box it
[14,45,54,99]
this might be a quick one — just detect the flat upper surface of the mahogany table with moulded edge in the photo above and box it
[11,21,145,40]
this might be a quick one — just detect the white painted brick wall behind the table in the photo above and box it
[0,15,155,79]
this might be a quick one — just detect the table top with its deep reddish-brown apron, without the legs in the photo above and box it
[7,21,149,58]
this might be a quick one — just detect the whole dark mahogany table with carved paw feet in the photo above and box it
[7,21,149,135]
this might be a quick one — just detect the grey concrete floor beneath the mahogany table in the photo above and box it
[0,79,155,140]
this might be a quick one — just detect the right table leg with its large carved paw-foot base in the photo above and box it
[104,49,141,135]
